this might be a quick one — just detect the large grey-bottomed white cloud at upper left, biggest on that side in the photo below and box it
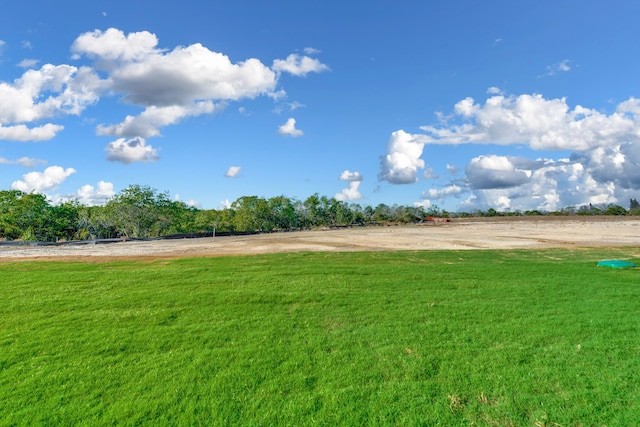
[73,28,277,106]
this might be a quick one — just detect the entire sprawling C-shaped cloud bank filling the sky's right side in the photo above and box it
[388,95,640,211]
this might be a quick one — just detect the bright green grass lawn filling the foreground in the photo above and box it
[0,248,640,426]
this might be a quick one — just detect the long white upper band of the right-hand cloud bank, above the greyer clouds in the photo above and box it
[414,95,640,151]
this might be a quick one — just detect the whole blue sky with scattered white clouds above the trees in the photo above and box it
[0,0,640,211]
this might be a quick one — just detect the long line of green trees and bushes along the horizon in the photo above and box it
[0,185,640,242]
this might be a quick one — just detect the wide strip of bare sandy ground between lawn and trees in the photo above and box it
[0,217,640,262]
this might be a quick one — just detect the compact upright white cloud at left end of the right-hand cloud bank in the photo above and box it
[378,130,424,184]
